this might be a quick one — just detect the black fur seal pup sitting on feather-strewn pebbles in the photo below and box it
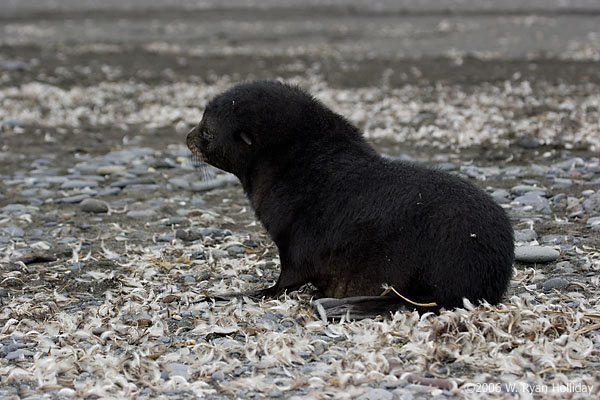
[187,81,514,316]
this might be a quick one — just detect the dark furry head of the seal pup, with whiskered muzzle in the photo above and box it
[186,81,332,177]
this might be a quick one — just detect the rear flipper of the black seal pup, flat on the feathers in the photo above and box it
[313,296,439,319]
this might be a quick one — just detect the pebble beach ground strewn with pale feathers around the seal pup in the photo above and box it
[0,0,600,400]
